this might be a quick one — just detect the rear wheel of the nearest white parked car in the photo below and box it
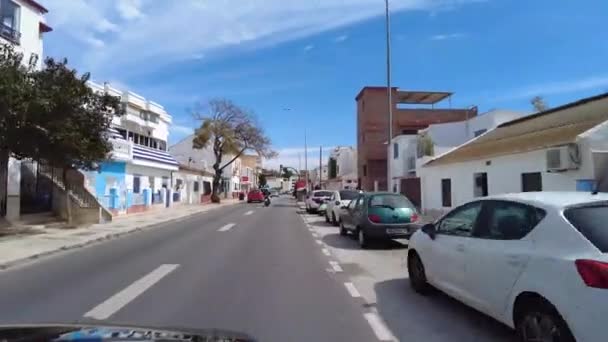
[515,298,576,342]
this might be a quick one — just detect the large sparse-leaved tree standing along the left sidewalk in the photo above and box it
[192,99,276,203]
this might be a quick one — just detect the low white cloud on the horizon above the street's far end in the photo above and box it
[262,146,334,170]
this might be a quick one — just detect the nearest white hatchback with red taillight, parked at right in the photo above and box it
[408,192,608,342]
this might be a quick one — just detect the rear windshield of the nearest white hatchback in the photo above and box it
[564,204,608,253]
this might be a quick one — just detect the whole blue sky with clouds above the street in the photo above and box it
[41,0,608,167]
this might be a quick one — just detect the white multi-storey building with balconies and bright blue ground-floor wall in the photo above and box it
[85,82,180,213]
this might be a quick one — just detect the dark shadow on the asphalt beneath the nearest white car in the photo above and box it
[370,278,516,342]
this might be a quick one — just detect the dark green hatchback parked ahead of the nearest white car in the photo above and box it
[340,192,419,248]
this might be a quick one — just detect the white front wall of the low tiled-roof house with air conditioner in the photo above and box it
[419,147,594,211]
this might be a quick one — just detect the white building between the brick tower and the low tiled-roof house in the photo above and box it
[390,110,527,205]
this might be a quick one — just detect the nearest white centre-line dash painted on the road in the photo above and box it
[84,264,179,319]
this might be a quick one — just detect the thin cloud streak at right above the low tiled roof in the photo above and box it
[497,75,608,100]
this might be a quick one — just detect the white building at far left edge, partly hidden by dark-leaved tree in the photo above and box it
[0,0,52,220]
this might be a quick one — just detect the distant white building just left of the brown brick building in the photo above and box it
[326,146,358,190]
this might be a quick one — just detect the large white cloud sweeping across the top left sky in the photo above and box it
[45,0,478,73]
